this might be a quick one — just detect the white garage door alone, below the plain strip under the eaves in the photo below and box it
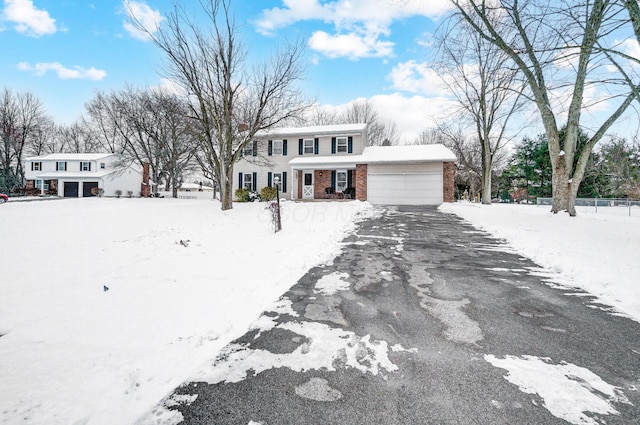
[367,172,442,205]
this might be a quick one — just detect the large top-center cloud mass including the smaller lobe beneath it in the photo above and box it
[255,0,450,59]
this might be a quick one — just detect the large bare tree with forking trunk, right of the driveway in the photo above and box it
[451,0,639,216]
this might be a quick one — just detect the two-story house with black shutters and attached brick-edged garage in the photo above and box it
[235,124,456,205]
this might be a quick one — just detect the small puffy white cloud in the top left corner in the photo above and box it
[2,0,56,37]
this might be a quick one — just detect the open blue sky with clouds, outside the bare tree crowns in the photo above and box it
[0,0,448,140]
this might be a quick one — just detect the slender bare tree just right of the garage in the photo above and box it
[436,12,525,204]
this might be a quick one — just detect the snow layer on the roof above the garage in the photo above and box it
[362,144,456,164]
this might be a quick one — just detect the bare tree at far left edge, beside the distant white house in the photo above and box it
[0,88,50,190]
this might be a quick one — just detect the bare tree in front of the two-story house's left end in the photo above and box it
[129,0,306,210]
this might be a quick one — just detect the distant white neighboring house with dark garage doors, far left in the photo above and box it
[25,153,143,198]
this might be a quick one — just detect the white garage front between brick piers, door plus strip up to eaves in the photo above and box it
[367,163,443,205]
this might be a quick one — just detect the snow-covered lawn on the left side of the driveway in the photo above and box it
[0,197,373,425]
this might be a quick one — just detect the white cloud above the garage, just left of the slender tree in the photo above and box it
[388,60,449,96]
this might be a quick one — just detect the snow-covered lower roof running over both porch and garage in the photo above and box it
[289,144,456,169]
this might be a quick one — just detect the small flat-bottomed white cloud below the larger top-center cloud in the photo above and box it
[309,31,394,59]
